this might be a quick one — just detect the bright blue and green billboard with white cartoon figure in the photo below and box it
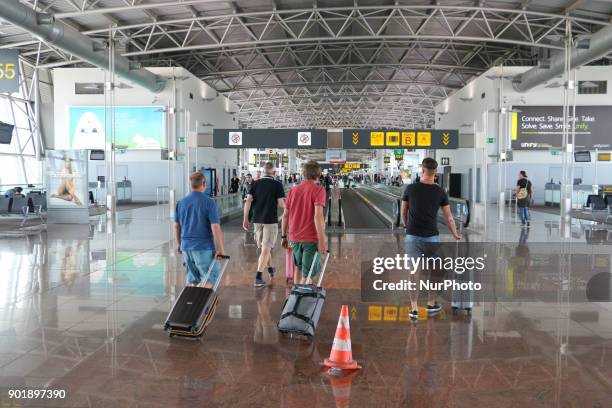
[68,106,165,149]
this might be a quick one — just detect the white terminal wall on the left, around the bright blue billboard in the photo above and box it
[47,68,238,201]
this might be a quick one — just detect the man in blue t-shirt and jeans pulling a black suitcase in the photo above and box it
[174,172,224,288]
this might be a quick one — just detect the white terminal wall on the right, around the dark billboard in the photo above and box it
[435,66,612,204]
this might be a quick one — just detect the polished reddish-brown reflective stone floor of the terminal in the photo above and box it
[0,207,612,408]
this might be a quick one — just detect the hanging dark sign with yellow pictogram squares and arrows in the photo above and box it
[342,129,459,149]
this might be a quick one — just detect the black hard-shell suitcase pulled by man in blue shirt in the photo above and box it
[164,256,229,339]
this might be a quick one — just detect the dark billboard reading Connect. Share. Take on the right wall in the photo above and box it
[510,106,612,150]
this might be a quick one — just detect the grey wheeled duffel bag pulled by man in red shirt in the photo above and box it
[278,252,329,337]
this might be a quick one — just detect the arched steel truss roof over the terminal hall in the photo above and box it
[0,0,612,128]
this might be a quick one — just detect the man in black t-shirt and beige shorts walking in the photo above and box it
[242,162,285,287]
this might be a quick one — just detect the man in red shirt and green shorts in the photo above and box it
[281,160,327,284]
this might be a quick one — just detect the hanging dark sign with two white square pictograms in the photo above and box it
[213,129,327,149]
